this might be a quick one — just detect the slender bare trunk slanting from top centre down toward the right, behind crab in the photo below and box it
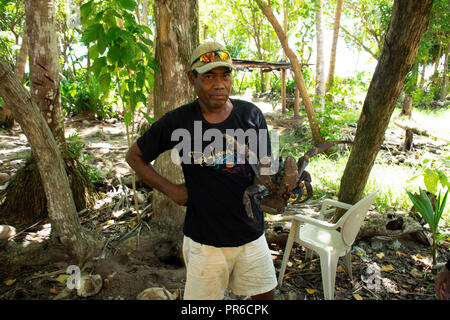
[256,0,323,146]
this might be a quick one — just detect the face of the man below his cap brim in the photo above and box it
[189,67,233,109]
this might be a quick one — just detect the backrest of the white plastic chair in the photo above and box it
[341,190,378,246]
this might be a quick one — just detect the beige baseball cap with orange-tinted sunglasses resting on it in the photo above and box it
[191,42,234,73]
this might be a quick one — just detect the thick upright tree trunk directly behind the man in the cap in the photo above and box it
[152,0,198,241]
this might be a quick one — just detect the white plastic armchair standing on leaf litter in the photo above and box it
[278,191,378,300]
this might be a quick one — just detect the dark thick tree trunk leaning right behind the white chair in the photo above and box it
[332,0,433,221]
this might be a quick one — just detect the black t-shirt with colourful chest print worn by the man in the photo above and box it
[137,99,270,247]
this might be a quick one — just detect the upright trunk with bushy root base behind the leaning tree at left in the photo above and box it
[2,0,96,223]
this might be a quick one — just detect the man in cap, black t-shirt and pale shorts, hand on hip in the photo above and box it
[126,42,277,300]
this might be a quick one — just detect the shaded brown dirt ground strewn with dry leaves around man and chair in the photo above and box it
[0,107,450,300]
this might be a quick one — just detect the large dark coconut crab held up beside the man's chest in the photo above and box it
[243,141,352,221]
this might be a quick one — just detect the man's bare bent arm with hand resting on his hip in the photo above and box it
[125,143,188,206]
